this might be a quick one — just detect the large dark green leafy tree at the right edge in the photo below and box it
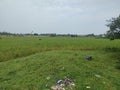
[107,15,120,40]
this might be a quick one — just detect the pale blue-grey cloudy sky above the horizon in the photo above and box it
[0,0,120,35]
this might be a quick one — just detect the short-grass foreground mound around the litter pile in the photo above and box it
[0,50,120,90]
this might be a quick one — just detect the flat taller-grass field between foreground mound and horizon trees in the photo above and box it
[0,37,120,61]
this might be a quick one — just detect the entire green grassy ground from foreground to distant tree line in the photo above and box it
[0,37,120,90]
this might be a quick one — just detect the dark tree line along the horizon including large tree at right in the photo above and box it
[0,15,120,40]
